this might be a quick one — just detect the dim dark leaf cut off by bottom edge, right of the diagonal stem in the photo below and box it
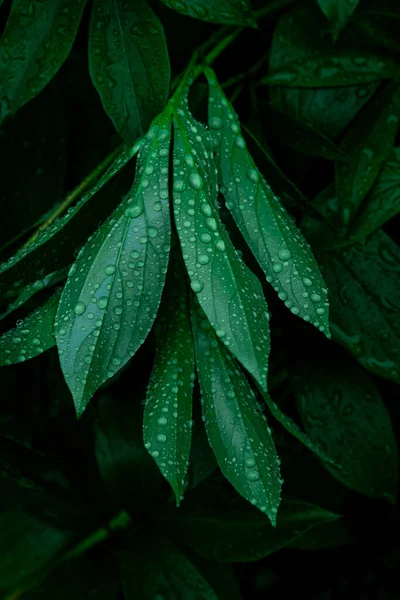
[120,532,218,600]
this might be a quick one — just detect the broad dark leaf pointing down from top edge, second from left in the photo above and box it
[89,0,170,143]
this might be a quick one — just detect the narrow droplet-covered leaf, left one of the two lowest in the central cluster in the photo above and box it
[143,263,194,506]
